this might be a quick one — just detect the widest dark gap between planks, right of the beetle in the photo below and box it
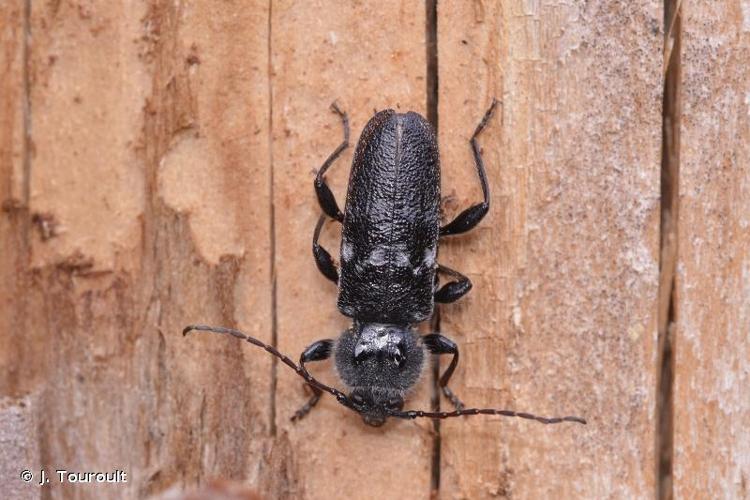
[655,0,681,500]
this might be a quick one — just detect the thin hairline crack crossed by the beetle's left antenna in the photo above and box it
[267,0,279,437]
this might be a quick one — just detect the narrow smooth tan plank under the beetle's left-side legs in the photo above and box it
[272,0,431,498]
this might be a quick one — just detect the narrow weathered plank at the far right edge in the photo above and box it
[673,2,750,498]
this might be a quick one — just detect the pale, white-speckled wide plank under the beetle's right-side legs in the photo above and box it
[438,0,663,498]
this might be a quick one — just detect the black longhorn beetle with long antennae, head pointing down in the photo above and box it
[183,99,586,426]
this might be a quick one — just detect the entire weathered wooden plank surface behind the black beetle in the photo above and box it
[0,0,750,498]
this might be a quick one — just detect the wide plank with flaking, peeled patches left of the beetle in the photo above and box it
[6,0,277,498]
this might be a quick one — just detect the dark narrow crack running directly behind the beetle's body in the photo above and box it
[425,0,441,498]
